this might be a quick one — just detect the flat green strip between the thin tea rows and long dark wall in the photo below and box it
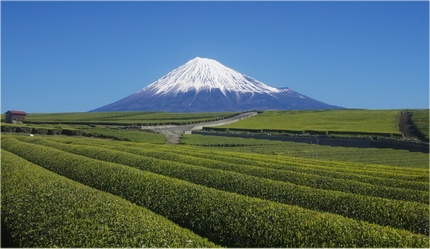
[181,134,429,169]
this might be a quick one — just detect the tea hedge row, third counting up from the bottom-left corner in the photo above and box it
[10,136,429,234]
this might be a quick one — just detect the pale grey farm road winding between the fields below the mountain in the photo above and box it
[146,112,257,144]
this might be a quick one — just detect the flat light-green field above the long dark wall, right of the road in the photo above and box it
[219,110,401,134]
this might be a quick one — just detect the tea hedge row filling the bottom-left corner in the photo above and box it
[1,150,216,248]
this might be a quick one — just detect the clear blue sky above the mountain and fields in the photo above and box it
[1,1,429,113]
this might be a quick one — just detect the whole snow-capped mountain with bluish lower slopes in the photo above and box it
[92,57,341,112]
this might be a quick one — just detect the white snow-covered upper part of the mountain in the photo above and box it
[139,57,280,95]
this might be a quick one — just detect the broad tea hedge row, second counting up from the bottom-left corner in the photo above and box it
[2,138,429,247]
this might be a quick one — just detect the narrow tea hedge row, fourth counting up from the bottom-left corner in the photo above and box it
[19,135,429,203]
